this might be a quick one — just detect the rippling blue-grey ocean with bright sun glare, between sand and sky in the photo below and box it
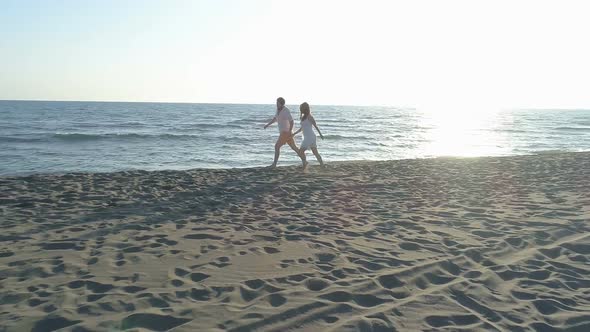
[0,101,590,176]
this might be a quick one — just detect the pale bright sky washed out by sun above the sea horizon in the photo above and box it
[0,0,590,110]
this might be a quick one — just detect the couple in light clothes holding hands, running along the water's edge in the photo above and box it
[264,97,324,169]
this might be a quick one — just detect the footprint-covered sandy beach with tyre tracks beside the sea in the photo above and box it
[0,153,590,332]
